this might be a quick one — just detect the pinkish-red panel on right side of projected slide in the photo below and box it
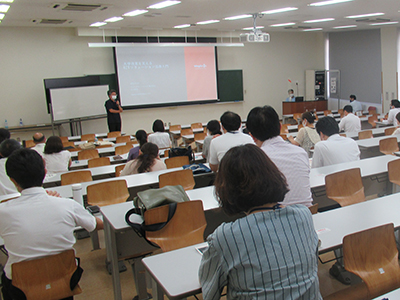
[185,47,217,100]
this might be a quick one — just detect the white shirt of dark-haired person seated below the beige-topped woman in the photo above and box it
[312,134,360,168]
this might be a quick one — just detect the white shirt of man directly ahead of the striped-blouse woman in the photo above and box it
[261,136,319,206]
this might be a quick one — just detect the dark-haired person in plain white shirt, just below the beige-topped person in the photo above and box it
[312,117,360,168]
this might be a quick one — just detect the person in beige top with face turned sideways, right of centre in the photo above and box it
[288,111,321,157]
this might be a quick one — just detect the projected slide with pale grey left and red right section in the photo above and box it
[115,47,217,106]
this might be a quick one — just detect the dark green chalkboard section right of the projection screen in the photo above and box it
[217,70,243,102]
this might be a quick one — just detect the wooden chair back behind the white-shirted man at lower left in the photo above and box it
[11,249,82,300]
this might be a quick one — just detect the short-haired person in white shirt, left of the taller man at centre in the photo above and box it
[208,111,253,172]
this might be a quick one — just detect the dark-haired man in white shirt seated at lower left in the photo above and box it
[0,149,103,300]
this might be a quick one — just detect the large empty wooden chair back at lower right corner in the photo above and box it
[343,223,400,299]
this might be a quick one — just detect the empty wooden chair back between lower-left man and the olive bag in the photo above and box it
[86,180,129,206]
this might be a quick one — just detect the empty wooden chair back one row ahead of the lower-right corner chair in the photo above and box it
[325,168,365,206]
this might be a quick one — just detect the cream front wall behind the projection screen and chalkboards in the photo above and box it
[0,27,324,136]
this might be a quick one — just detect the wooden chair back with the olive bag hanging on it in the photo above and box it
[144,200,207,252]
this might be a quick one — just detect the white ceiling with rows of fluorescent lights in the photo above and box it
[0,0,400,32]
